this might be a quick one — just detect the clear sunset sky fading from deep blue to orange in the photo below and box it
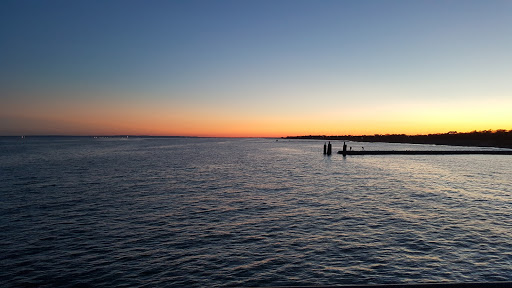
[0,0,512,137]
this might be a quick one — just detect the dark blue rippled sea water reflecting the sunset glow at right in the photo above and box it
[0,137,512,287]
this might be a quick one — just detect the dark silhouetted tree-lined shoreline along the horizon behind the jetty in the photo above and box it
[283,130,512,149]
